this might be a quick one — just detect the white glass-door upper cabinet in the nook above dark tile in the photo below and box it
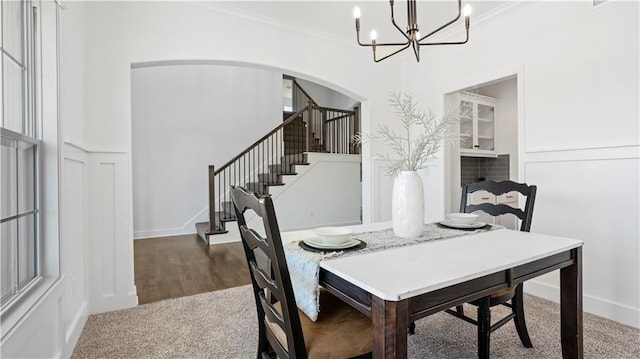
[459,92,498,157]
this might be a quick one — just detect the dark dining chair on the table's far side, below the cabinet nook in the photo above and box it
[446,181,537,358]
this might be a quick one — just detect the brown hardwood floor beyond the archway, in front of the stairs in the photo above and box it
[133,234,251,304]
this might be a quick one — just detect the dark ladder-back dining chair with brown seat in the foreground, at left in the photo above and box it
[231,186,373,359]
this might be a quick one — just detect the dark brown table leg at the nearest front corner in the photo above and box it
[371,296,409,358]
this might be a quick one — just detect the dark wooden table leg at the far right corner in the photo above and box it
[560,247,584,359]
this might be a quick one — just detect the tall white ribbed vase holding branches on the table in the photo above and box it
[391,171,424,238]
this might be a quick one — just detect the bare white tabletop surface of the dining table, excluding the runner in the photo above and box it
[282,223,583,301]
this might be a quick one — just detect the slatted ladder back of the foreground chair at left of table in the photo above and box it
[231,186,307,358]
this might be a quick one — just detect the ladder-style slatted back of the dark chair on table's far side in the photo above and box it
[460,181,537,232]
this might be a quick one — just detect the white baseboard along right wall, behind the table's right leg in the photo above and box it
[524,280,640,328]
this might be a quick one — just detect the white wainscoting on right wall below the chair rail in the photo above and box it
[524,152,640,327]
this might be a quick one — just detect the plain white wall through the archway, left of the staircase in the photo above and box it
[131,64,282,238]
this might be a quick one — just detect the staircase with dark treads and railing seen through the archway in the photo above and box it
[196,81,359,243]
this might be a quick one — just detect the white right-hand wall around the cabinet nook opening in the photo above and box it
[403,1,640,327]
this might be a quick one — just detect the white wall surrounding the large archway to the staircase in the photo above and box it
[76,2,400,318]
